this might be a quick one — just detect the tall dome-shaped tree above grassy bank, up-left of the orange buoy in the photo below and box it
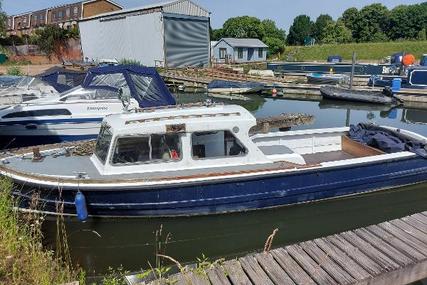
[353,3,390,42]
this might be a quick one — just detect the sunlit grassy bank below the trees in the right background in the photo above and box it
[281,41,427,62]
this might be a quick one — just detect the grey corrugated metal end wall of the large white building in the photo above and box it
[163,13,210,67]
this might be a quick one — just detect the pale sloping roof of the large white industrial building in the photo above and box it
[81,0,210,22]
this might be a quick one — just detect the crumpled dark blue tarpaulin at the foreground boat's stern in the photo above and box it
[349,123,427,158]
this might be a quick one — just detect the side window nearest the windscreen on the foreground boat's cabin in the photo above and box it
[112,134,181,164]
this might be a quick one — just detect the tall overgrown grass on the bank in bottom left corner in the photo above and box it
[0,178,83,285]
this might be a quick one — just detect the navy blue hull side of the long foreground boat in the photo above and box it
[10,156,427,217]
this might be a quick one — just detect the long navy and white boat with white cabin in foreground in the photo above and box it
[0,104,427,216]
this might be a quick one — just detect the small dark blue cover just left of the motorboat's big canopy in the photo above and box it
[37,66,86,93]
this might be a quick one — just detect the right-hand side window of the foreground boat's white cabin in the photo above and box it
[191,131,247,159]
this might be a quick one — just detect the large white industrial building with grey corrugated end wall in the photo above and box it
[79,0,210,67]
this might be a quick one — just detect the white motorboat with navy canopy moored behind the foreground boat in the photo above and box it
[0,66,175,147]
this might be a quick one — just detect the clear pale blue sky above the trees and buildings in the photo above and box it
[2,0,426,31]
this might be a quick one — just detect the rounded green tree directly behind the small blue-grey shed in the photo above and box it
[222,16,265,39]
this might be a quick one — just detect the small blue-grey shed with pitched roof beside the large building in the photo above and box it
[212,38,268,63]
